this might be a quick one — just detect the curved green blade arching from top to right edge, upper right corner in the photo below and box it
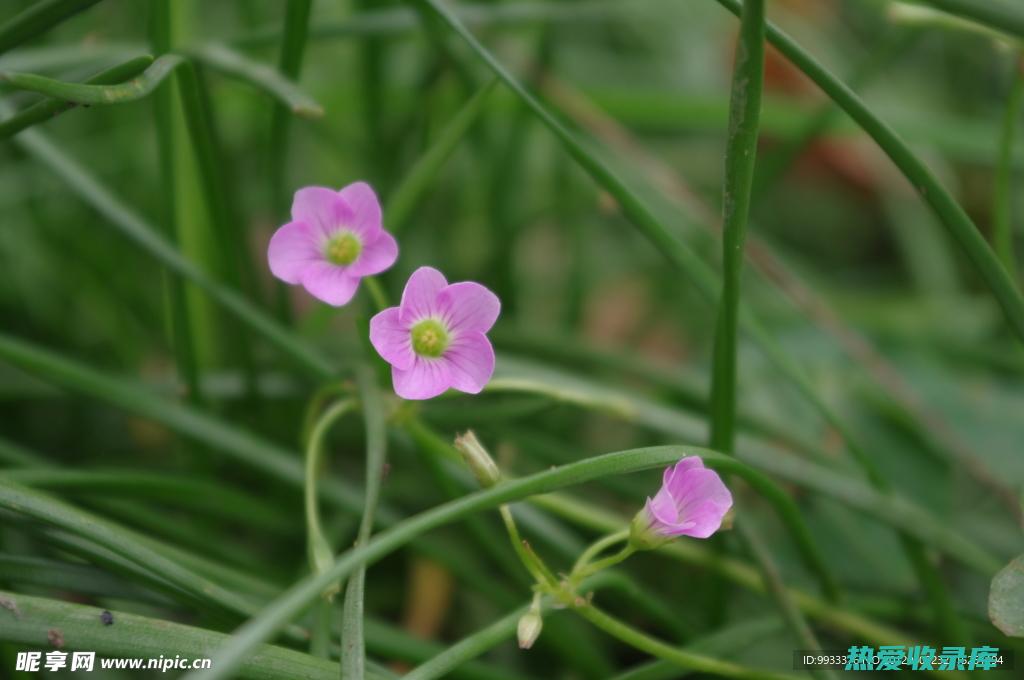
[717,0,1024,341]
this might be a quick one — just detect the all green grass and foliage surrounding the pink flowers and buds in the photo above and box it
[0,0,1024,680]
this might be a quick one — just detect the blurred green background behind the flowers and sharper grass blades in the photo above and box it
[0,0,1024,678]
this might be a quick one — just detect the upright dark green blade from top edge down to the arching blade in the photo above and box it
[710,0,765,453]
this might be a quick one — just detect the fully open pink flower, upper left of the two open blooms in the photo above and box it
[267,182,398,306]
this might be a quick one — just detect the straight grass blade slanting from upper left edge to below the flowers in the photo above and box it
[14,122,334,378]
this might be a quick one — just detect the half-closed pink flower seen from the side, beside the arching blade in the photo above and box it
[633,456,732,545]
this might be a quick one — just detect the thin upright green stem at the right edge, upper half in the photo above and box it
[992,51,1024,281]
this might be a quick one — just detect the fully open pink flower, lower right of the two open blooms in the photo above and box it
[370,267,502,399]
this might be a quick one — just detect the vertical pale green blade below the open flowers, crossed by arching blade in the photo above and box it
[341,367,387,680]
